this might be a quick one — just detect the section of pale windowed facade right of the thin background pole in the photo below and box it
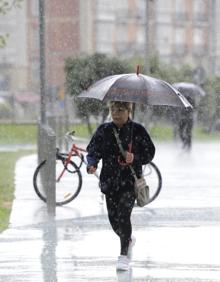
[153,0,220,76]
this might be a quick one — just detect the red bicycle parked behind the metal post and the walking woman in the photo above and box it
[33,131,162,206]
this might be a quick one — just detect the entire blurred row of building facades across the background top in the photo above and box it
[0,0,220,117]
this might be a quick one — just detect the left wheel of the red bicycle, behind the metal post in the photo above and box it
[33,159,82,206]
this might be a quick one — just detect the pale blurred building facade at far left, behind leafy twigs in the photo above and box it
[0,0,28,91]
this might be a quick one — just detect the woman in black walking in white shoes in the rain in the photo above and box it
[87,101,155,270]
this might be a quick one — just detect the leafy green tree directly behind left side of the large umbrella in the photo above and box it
[65,53,131,134]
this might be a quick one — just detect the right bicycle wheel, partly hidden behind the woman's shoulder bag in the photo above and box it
[142,162,162,204]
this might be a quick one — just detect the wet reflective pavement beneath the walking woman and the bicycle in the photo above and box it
[0,142,220,282]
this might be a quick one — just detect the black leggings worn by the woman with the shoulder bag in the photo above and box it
[106,191,135,255]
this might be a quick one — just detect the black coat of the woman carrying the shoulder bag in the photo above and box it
[87,120,155,193]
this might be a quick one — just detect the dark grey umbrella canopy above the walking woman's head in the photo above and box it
[78,72,192,107]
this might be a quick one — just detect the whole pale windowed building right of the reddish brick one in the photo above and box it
[90,0,220,77]
